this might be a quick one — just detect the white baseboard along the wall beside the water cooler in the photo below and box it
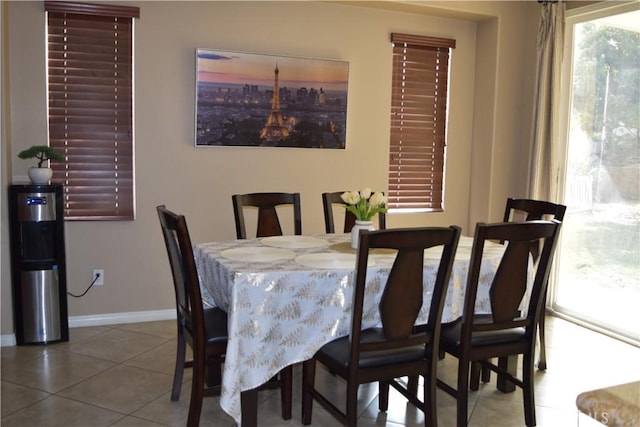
[0,309,176,347]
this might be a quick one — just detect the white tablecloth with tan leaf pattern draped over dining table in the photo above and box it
[194,234,504,425]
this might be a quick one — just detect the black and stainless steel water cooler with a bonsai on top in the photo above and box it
[9,185,69,345]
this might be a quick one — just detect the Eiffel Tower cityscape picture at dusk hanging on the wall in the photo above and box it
[195,49,349,149]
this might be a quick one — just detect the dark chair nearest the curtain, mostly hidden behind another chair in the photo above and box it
[504,197,567,372]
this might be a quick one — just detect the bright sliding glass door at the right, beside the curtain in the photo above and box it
[552,2,640,344]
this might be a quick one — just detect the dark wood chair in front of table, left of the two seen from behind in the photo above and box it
[302,226,460,426]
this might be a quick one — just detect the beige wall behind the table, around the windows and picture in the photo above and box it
[1,1,539,342]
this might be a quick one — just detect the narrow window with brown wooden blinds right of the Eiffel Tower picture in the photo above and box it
[388,33,456,211]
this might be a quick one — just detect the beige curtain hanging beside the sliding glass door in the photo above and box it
[529,2,565,202]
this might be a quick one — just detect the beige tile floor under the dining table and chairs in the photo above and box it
[0,317,640,427]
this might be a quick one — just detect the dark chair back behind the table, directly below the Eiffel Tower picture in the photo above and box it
[231,193,302,239]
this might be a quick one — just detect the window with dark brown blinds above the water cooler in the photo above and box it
[45,1,140,220]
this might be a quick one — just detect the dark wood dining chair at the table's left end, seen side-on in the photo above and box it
[156,205,292,427]
